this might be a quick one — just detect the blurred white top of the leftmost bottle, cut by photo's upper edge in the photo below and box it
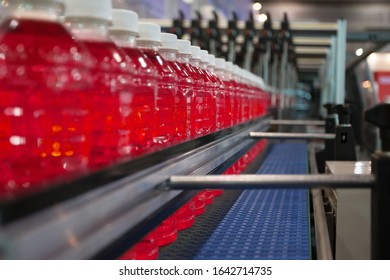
[8,0,64,21]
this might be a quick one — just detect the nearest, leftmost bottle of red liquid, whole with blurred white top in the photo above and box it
[0,0,92,197]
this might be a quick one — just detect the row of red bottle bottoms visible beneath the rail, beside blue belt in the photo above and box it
[119,140,266,260]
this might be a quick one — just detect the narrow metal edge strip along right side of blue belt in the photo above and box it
[309,144,333,260]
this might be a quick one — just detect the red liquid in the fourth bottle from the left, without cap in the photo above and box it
[142,48,177,147]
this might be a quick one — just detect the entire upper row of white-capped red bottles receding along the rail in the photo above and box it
[0,0,270,198]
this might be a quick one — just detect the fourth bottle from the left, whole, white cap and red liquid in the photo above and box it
[137,22,178,148]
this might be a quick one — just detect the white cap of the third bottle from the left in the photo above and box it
[110,9,138,34]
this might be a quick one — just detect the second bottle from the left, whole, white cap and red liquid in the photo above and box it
[65,0,134,169]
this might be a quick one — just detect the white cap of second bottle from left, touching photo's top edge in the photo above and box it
[64,0,112,22]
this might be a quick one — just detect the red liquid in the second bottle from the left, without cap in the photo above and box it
[82,40,135,169]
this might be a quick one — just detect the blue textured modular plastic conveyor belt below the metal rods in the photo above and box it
[194,142,311,260]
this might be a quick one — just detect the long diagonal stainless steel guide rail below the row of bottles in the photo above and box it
[0,119,268,259]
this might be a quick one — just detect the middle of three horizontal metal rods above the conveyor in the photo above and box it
[249,132,335,140]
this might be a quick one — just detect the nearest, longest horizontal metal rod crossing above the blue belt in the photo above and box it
[165,174,375,190]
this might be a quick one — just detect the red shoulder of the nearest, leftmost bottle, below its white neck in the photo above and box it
[0,18,91,67]
